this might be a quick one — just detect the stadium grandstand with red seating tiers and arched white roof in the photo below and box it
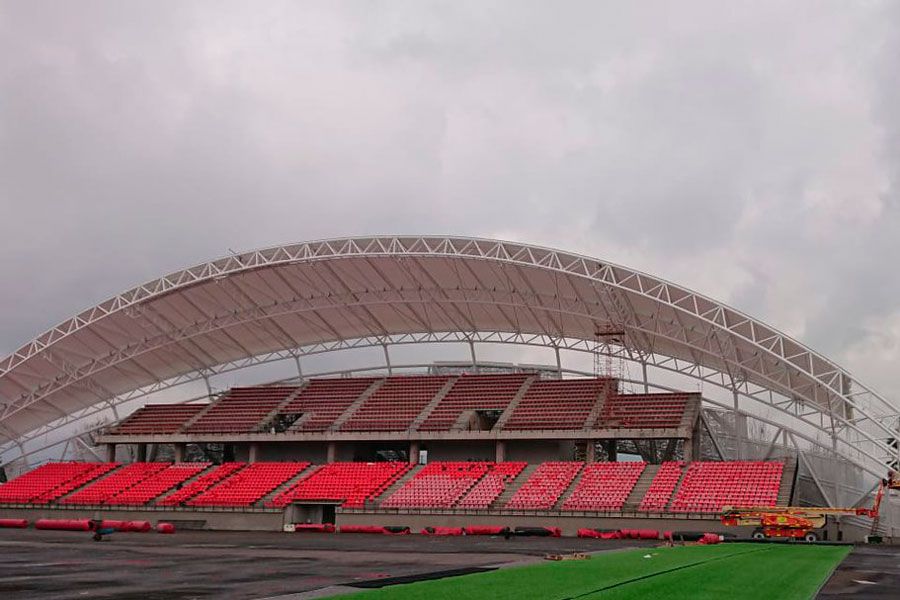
[0,236,900,597]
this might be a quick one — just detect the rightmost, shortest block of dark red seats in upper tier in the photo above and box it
[599,394,690,429]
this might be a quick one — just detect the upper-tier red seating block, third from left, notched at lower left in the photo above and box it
[279,377,377,431]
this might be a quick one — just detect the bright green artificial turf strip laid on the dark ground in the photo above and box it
[326,544,850,600]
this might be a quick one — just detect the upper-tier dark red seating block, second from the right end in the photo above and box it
[504,379,611,430]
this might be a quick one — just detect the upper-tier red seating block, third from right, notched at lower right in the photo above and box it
[419,373,529,431]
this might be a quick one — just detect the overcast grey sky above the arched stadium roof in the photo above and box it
[0,0,900,397]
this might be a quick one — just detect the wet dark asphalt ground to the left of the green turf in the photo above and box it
[0,529,656,600]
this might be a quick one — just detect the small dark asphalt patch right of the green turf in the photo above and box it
[817,544,900,600]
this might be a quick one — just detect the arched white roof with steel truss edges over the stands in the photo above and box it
[0,236,900,473]
